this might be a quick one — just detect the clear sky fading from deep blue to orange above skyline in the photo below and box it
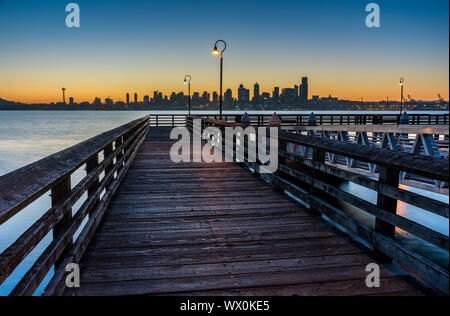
[0,0,449,103]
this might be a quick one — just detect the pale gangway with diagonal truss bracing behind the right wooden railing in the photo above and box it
[293,125,449,191]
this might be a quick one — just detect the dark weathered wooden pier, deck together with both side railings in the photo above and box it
[0,117,448,296]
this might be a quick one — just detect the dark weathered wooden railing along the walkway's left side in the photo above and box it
[0,116,149,295]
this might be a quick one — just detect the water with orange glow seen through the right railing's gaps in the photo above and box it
[340,182,449,269]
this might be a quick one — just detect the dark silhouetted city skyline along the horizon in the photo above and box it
[0,76,448,111]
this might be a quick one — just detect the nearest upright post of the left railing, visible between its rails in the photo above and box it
[51,175,73,267]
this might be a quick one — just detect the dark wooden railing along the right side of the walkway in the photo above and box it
[195,118,449,295]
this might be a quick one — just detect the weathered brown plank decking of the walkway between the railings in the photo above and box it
[64,128,421,295]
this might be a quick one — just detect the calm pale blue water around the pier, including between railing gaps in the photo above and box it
[0,111,449,295]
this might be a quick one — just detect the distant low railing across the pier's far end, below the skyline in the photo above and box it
[157,111,450,127]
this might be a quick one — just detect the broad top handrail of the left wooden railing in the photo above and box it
[0,116,149,224]
